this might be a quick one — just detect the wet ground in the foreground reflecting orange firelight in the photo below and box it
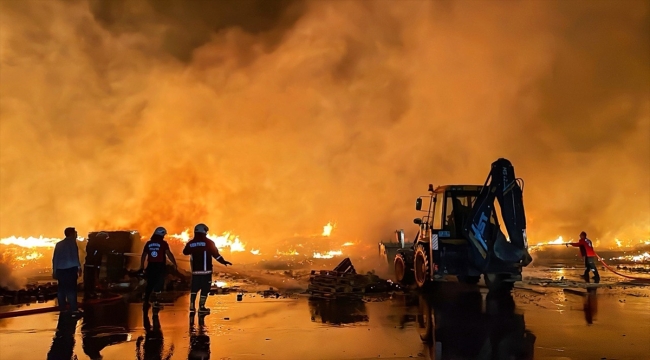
[0,268,650,360]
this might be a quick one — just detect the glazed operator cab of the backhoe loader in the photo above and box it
[413,185,482,241]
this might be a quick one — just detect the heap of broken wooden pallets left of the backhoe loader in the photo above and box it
[307,258,368,300]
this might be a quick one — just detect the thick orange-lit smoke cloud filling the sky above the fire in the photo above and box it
[0,0,650,248]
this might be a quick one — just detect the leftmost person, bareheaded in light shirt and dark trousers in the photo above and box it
[52,227,81,317]
